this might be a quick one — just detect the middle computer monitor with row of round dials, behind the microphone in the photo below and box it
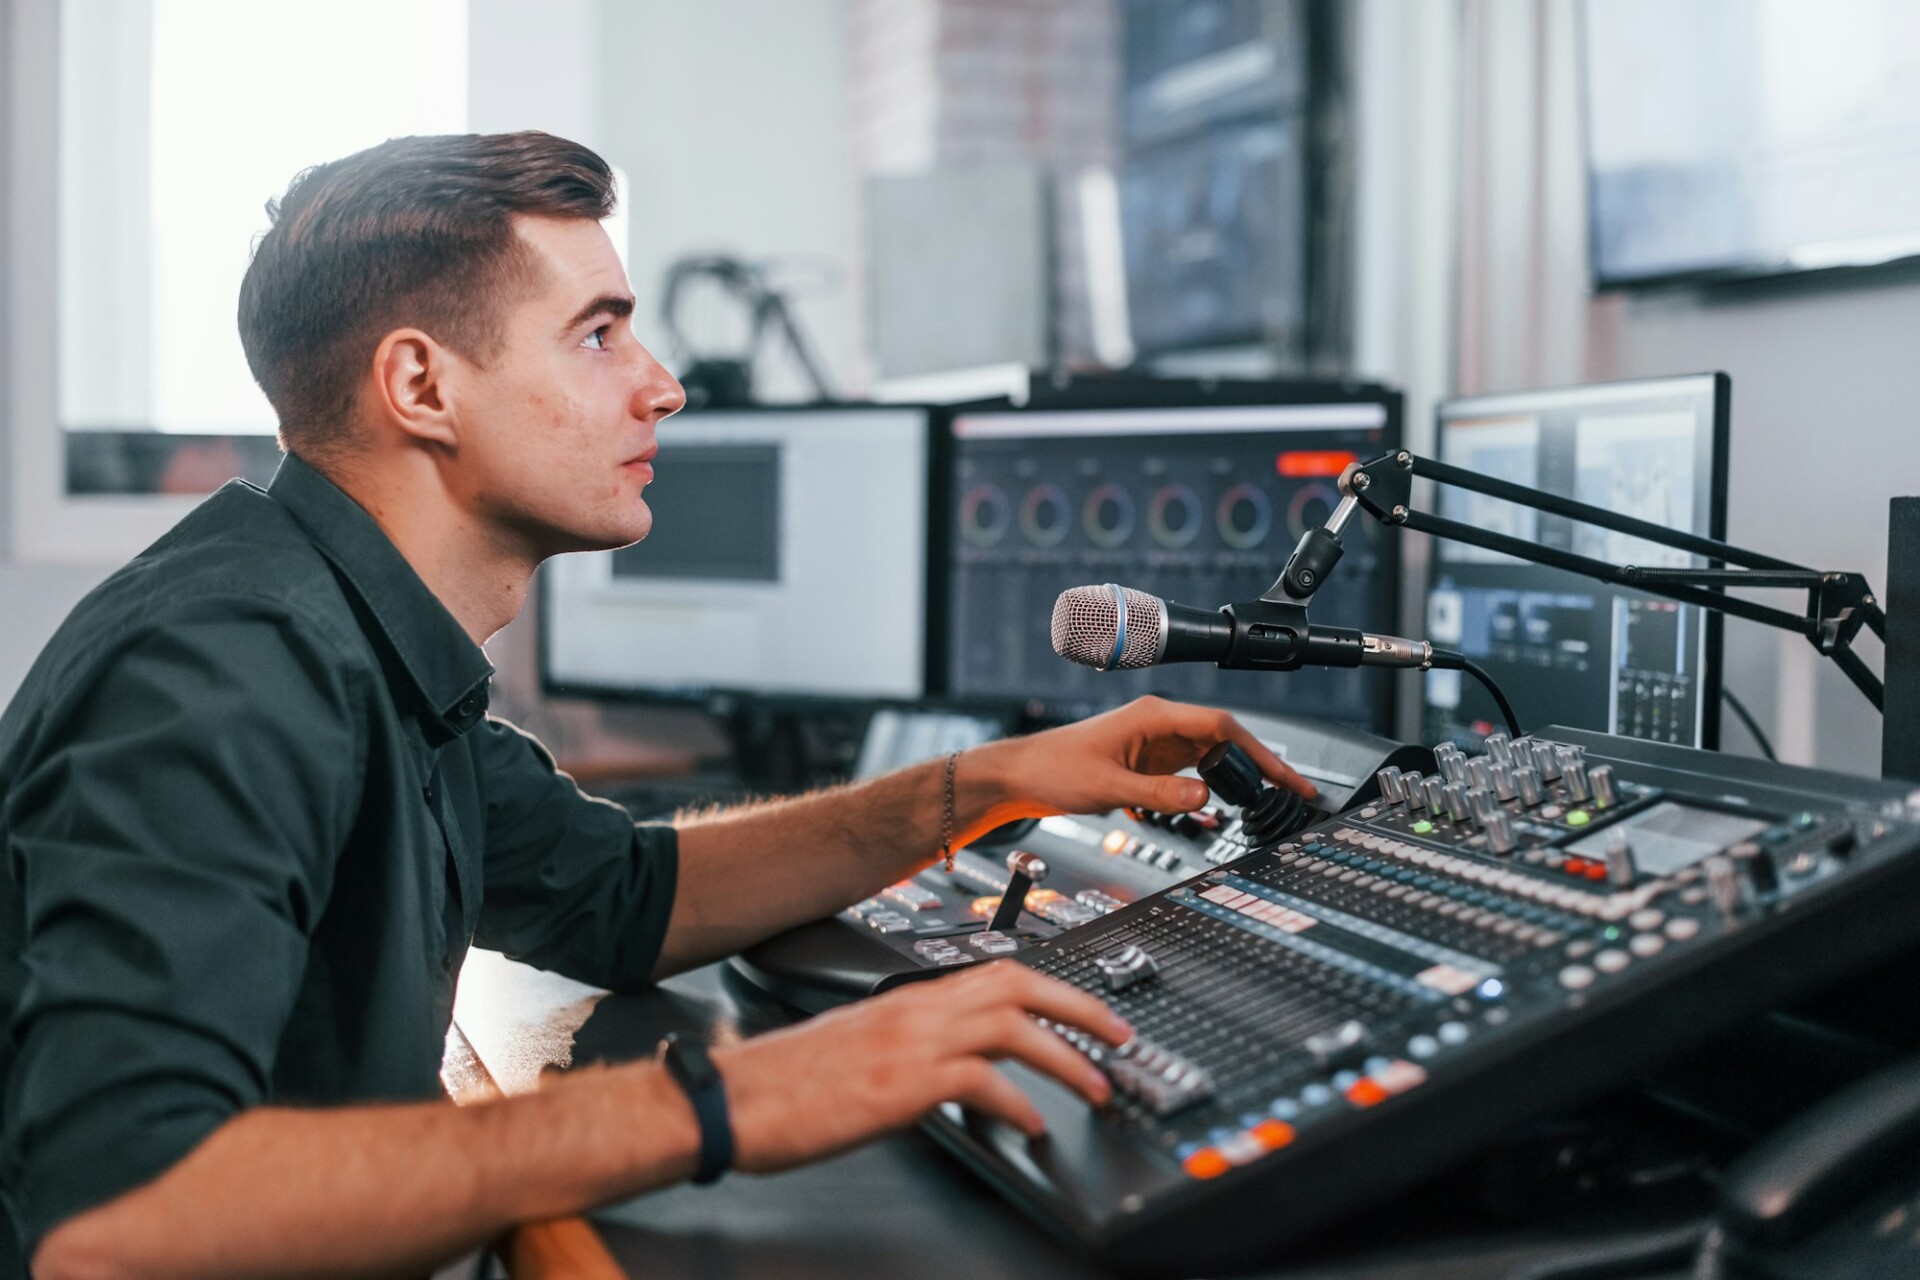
[943,384,1402,731]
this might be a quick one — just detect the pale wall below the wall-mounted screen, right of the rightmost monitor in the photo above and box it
[1599,282,1920,773]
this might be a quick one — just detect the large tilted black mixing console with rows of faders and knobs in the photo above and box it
[906,729,1920,1274]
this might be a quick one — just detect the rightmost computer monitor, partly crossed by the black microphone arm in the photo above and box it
[1423,374,1732,747]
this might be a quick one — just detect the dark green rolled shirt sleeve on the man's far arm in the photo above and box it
[472,720,680,988]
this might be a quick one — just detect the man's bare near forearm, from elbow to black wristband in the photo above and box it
[35,1063,699,1280]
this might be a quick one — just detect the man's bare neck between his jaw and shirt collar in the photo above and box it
[326,461,540,645]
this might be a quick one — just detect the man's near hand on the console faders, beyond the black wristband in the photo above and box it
[712,963,1133,1173]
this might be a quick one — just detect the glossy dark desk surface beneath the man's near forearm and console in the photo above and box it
[455,952,1684,1280]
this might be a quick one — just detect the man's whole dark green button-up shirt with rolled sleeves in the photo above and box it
[0,457,678,1267]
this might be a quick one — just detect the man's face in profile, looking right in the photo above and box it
[455,217,685,558]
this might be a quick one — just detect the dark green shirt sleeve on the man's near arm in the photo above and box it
[0,601,361,1253]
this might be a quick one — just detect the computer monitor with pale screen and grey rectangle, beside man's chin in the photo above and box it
[540,405,935,702]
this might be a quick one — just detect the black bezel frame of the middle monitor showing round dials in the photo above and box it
[927,374,1405,735]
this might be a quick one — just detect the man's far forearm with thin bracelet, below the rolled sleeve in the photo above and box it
[659,743,1027,975]
